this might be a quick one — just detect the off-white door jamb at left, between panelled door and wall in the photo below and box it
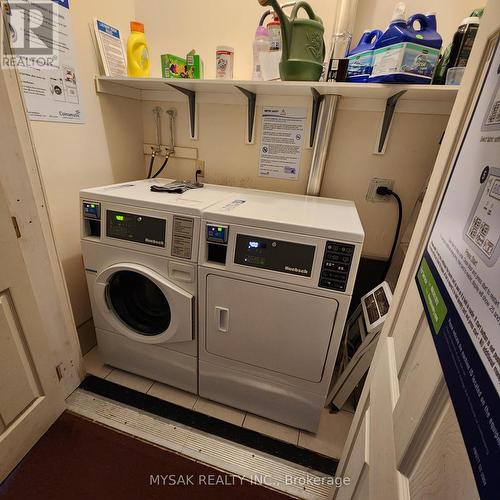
[0,27,85,396]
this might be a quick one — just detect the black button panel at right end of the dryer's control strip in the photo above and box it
[318,241,354,292]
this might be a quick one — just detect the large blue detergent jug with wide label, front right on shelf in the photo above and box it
[368,2,443,84]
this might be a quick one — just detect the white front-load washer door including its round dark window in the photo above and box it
[94,264,194,344]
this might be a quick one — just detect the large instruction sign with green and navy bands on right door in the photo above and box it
[416,37,500,498]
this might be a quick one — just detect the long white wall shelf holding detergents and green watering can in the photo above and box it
[96,76,458,102]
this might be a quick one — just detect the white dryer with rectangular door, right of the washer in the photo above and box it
[198,191,364,432]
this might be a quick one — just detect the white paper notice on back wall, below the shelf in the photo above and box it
[259,107,307,180]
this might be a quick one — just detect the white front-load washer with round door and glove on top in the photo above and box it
[80,179,238,393]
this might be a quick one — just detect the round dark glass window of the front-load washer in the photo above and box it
[106,271,171,336]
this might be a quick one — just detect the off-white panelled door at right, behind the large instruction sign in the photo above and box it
[334,2,500,500]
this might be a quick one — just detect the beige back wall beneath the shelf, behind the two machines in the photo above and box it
[143,96,448,259]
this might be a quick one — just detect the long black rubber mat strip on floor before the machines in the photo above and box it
[80,375,338,476]
